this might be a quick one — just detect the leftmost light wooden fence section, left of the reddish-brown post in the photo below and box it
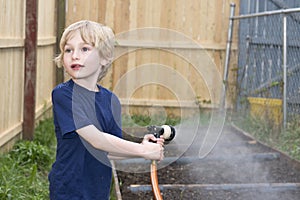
[0,0,25,140]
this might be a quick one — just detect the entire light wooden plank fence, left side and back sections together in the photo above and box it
[0,0,239,150]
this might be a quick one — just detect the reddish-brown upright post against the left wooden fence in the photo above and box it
[23,0,38,140]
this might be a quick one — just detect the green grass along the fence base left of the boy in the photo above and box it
[0,119,55,200]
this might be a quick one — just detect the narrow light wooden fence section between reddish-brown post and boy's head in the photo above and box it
[36,0,56,118]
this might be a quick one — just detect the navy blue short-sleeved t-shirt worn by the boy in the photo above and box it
[49,79,122,200]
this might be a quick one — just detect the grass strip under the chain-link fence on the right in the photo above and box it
[235,116,300,161]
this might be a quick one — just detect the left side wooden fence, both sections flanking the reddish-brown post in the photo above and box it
[0,0,56,148]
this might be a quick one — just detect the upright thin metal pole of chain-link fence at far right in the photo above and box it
[282,15,287,129]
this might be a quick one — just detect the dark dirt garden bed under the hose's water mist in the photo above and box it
[117,127,300,200]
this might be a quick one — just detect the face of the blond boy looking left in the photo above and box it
[63,31,101,82]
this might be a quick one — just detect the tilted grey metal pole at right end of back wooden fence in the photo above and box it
[220,3,235,109]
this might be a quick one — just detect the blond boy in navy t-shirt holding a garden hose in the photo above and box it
[49,20,164,200]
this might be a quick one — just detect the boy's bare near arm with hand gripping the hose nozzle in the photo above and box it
[77,125,164,160]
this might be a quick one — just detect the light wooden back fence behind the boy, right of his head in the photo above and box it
[66,0,239,115]
